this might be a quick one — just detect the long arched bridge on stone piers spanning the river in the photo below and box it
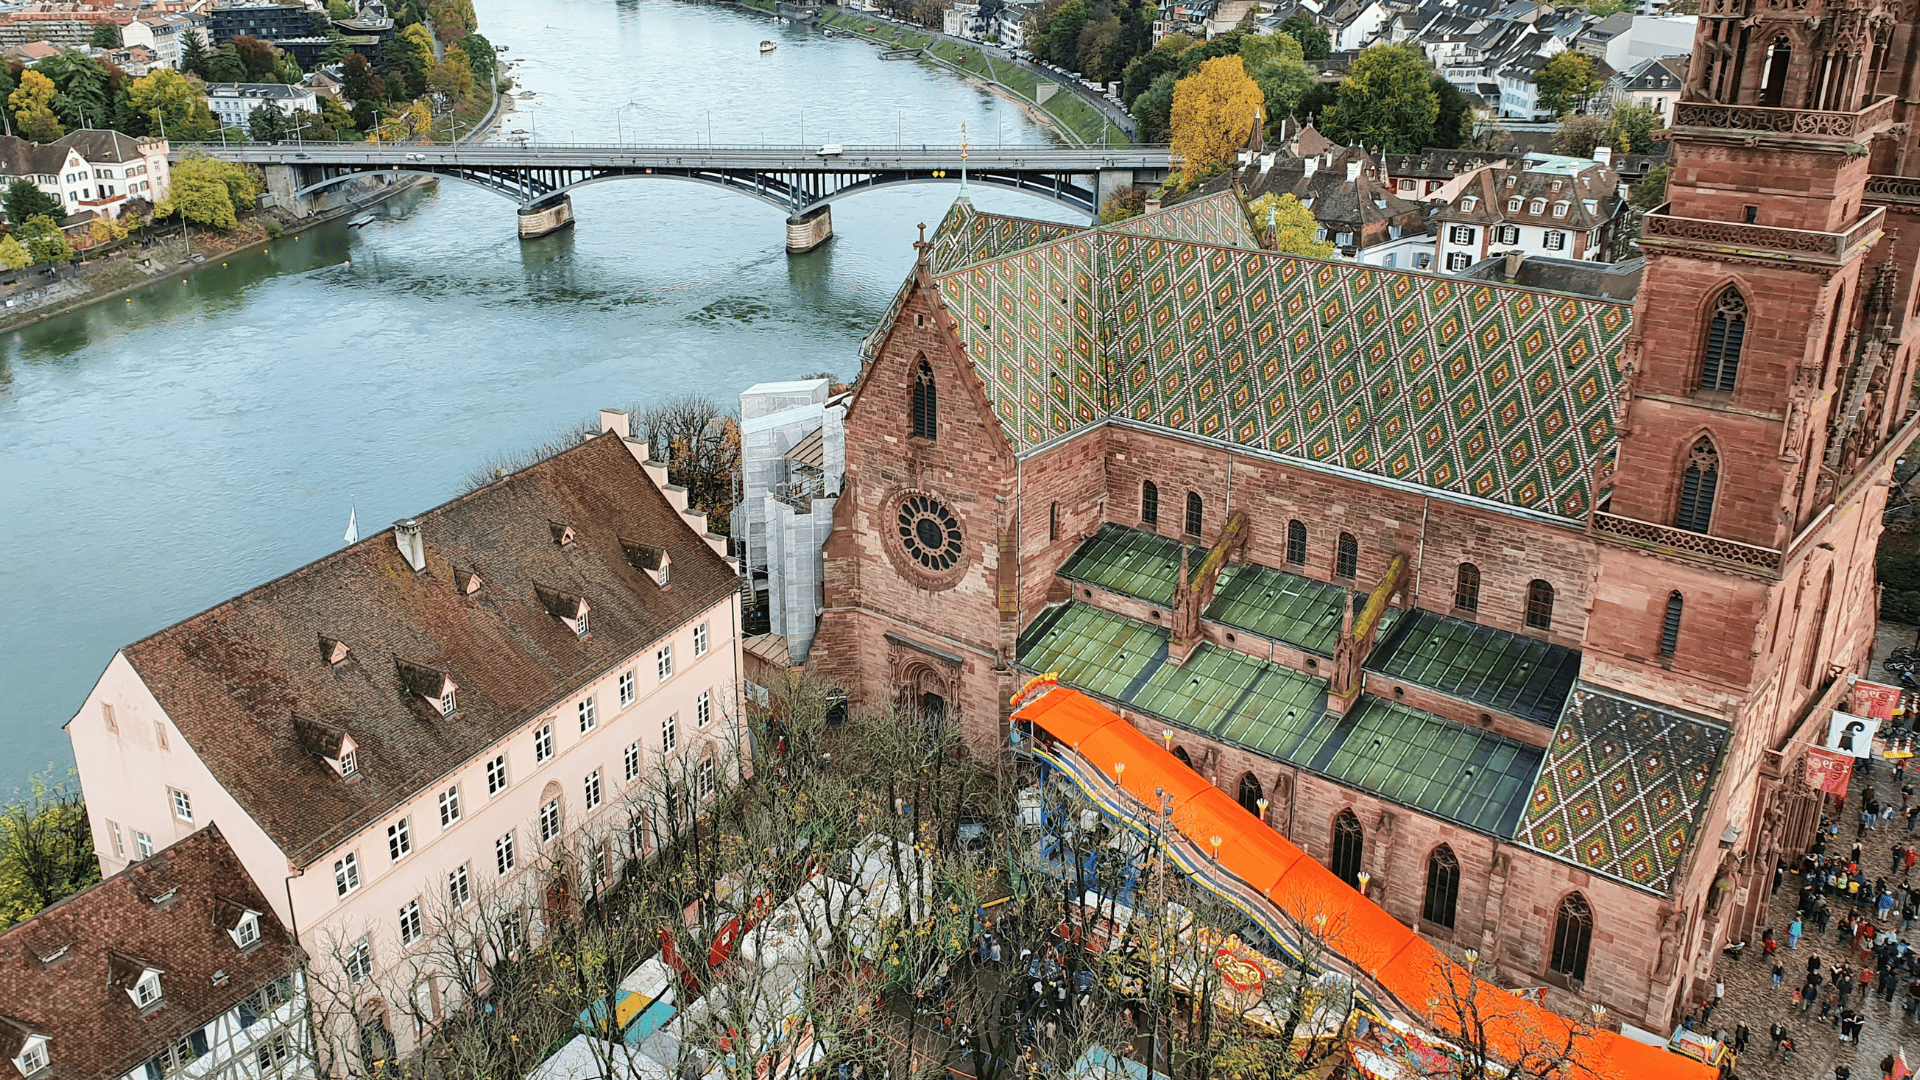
[205,142,1167,252]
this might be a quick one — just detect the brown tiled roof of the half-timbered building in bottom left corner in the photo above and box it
[0,824,300,1080]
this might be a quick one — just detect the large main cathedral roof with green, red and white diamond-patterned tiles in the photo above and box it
[913,192,1632,519]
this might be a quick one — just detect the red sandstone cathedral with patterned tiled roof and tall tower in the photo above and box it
[808,0,1920,1032]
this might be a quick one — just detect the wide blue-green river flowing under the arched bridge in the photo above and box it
[0,0,1073,780]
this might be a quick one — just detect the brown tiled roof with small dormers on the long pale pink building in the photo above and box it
[125,434,737,867]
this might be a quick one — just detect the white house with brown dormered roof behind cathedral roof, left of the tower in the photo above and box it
[1434,146,1626,273]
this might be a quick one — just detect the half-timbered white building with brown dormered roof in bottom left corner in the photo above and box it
[0,824,311,1080]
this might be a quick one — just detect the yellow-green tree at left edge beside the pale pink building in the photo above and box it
[0,764,100,928]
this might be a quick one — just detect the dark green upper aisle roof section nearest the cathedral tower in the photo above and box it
[1367,611,1580,724]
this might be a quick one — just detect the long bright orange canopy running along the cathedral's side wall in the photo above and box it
[1014,686,1716,1080]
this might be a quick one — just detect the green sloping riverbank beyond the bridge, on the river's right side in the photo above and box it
[730,0,1133,146]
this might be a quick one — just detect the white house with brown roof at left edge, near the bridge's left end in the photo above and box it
[0,129,171,217]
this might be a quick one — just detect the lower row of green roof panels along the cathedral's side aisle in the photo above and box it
[1018,601,1544,836]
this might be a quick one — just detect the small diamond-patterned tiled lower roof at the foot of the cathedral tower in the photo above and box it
[1515,682,1726,894]
